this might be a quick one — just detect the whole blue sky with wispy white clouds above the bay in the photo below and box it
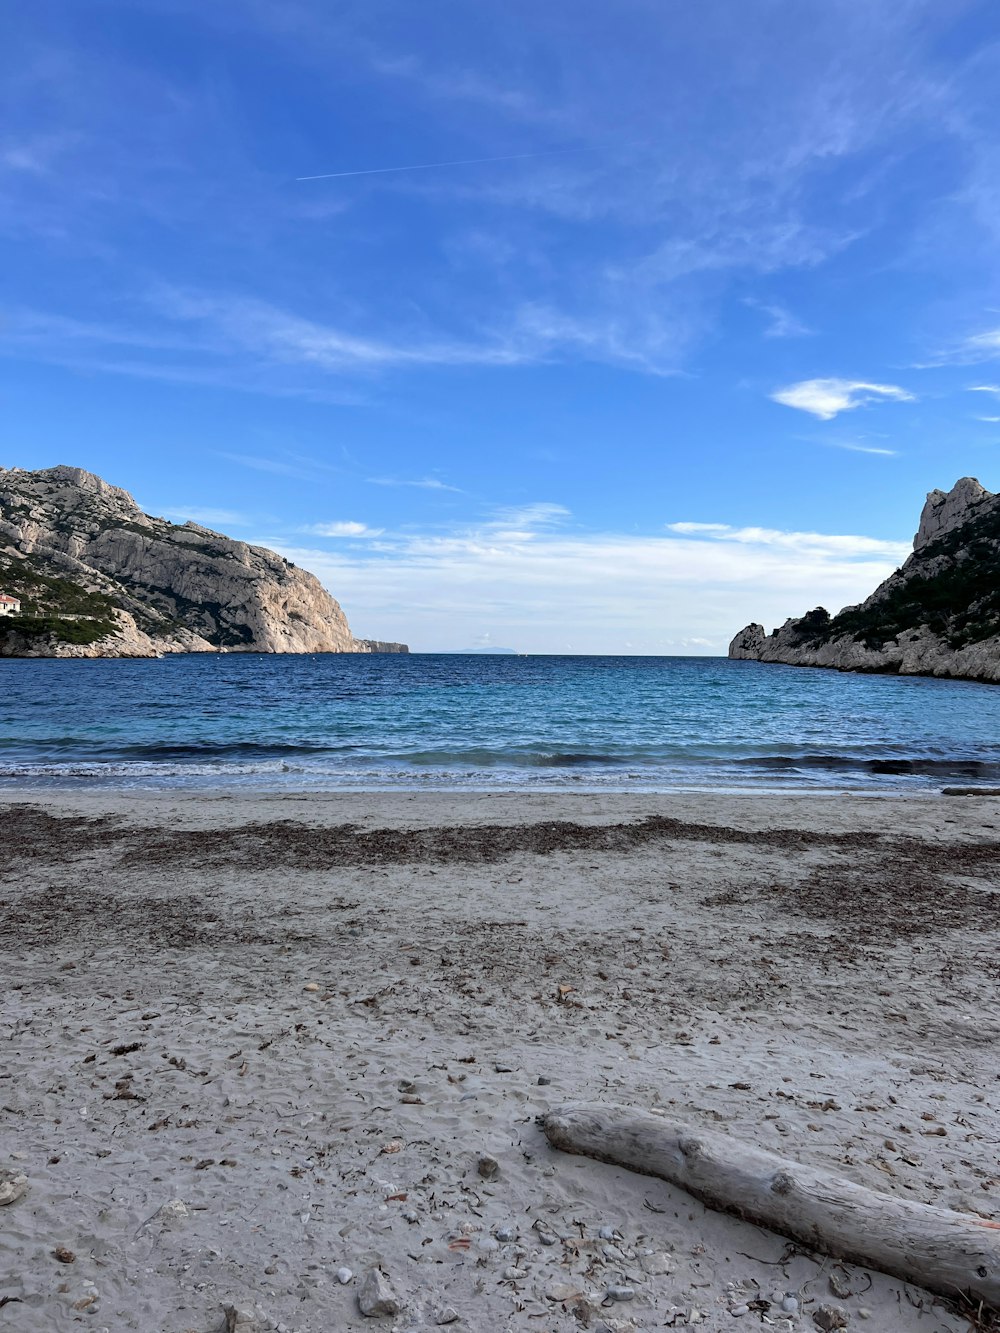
[0,0,1000,653]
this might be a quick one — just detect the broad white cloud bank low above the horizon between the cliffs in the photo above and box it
[260,507,909,653]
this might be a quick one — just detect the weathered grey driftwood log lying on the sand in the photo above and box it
[541,1105,1000,1309]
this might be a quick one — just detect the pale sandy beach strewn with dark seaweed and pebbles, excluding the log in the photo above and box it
[0,792,1000,1333]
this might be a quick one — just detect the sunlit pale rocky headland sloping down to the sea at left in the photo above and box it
[0,467,405,657]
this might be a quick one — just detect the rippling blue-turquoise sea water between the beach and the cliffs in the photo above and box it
[0,653,1000,790]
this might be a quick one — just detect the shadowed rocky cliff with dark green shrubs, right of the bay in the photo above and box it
[729,477,1000,682]
